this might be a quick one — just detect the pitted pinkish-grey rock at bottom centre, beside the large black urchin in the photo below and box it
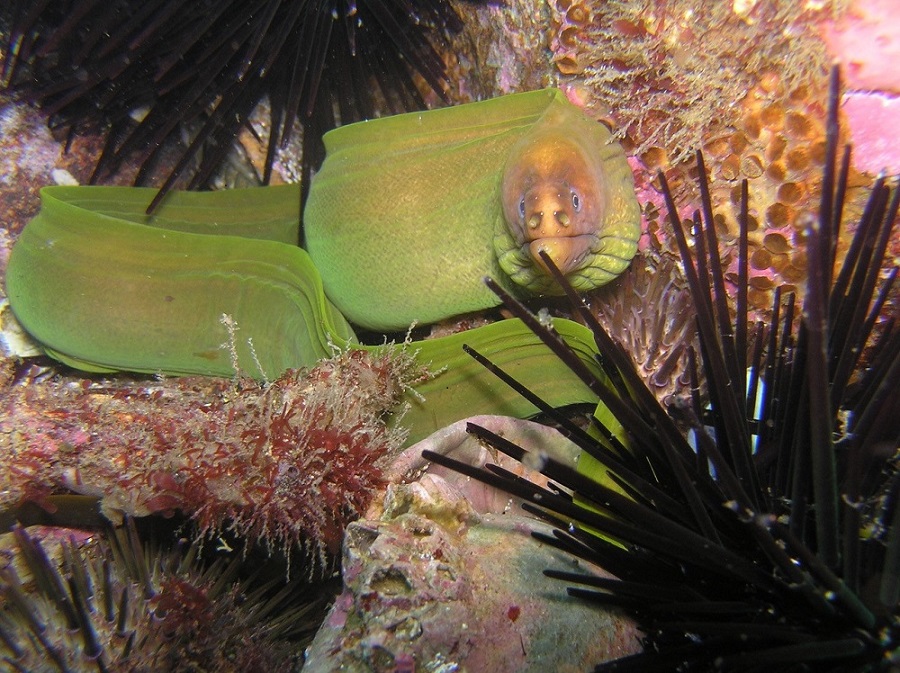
[303,460,640,673]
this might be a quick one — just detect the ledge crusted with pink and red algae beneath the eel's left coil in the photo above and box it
[0,348,423,551]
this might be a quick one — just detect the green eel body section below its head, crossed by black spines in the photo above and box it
[402,319,609,443]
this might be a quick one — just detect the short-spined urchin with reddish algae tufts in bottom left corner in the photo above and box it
[0,520,324,673]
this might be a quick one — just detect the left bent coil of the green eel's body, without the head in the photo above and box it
[7,187,355,378]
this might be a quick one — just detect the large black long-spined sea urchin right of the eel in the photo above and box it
[426,71,900,671]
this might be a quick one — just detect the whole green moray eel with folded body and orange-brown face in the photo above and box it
[7,91,639,441]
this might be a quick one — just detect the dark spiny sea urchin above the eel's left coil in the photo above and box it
[0,0,474,210]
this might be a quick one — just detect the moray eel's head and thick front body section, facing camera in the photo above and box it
[304,89,640,330]
